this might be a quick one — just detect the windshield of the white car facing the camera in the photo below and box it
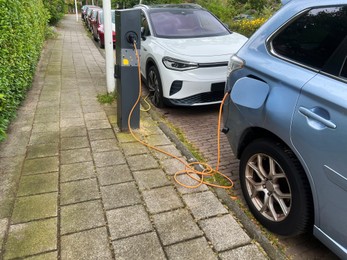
[149,9,230,38]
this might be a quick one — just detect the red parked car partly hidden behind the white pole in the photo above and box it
[90,9,116,48]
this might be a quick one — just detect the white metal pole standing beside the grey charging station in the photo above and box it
[102,0,115,93]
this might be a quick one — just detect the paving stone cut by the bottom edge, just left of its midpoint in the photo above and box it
[113,232,166,260]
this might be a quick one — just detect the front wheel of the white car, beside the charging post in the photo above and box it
[146,65,164,108]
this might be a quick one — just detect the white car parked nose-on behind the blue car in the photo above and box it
[134,4,247,107]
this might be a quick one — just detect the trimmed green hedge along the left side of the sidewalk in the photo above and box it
[0,0,49,140]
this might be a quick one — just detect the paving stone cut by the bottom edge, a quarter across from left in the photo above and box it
[61,227,112,260]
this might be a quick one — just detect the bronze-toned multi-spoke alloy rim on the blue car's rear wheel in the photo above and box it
[245,154,292,222]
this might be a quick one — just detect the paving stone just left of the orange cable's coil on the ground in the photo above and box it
[133,169,171,190]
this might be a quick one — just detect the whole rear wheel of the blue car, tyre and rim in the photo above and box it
[239,139,313,236]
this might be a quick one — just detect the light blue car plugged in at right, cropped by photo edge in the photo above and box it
[224,0,347,259]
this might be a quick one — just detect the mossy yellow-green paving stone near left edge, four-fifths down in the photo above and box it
[11,192,58,223]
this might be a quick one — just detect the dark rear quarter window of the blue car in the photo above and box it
[271,6,347,70]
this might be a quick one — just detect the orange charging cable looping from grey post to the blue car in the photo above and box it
[128,42,234,189]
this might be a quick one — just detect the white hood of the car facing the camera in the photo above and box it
[156,33,247,57]
